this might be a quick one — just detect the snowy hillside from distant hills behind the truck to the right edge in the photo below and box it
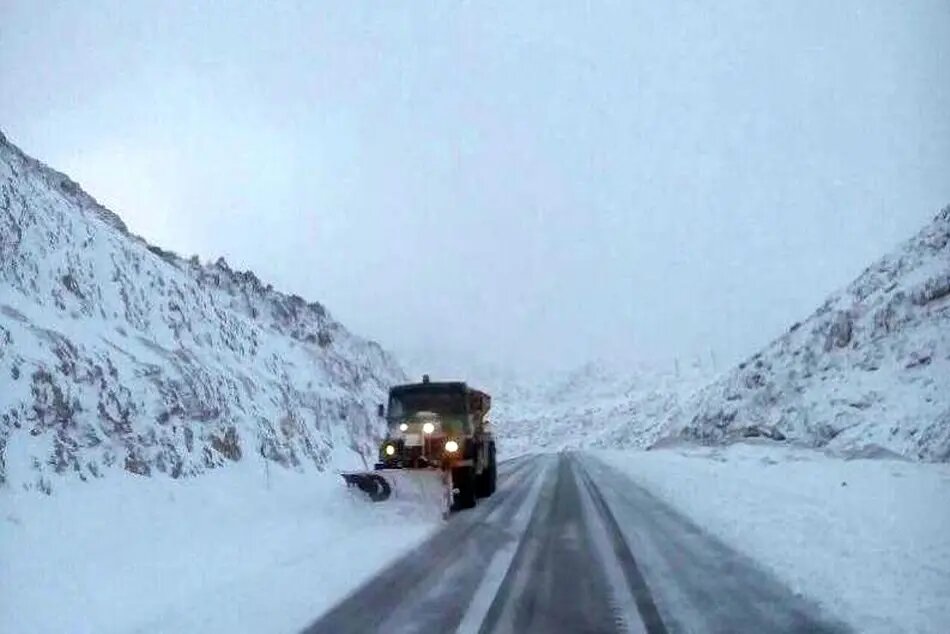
[424,207,950,461]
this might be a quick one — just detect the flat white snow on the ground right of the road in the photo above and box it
[596,444,950,633]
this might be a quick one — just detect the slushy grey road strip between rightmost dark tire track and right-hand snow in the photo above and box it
[581,455,849,634]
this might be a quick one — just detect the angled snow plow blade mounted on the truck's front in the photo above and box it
[340,469,452,515]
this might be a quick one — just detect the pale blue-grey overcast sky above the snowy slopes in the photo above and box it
[0,0,950,370]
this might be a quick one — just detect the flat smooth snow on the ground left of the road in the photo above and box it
[0,454,440,634]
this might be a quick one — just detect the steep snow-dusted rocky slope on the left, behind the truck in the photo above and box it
[0,135,404,491]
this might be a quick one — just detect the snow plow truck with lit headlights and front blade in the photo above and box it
[340,375,506,515]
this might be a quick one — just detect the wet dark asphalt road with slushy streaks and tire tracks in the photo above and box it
[305,453,845,634]
